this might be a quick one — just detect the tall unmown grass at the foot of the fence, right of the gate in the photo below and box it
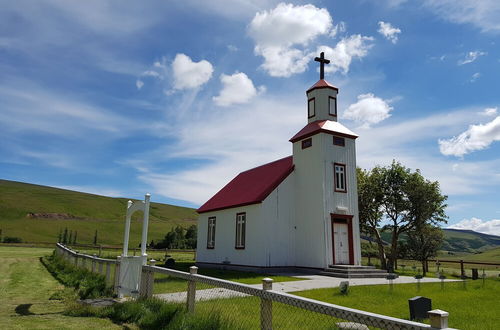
[64,298,238,330]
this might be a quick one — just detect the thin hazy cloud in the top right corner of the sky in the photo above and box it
[424,0,500,32]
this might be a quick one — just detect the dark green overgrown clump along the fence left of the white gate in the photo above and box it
[41,252,113,299]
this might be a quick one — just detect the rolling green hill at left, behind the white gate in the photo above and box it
[0,180,198,247]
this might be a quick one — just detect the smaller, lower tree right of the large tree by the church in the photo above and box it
[404,224,444,276]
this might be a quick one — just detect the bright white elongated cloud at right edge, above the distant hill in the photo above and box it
[438,116,500,157]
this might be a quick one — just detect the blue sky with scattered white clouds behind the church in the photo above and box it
[0,0,500,234]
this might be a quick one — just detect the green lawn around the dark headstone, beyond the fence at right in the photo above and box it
[294,279,500,330]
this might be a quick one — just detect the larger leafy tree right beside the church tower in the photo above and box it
[358,161,447,272]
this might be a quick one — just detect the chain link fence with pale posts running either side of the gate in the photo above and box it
[56,243,448,330]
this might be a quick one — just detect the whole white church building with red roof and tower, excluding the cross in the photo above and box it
[196,62,361,270]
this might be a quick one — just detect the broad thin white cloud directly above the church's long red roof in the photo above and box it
[135,95,307,205]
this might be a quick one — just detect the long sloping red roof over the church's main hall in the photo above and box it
[197,156,294,213]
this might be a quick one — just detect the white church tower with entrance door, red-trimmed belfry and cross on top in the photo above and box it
[290,53,361,268]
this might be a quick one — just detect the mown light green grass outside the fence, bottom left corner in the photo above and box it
[0,247,122,329]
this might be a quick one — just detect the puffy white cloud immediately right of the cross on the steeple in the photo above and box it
[318,34,373,74]
